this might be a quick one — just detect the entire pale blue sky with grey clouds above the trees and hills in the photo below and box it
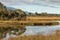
[0,0,60,13]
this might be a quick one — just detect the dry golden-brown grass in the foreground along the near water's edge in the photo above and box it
[9,30,60,40]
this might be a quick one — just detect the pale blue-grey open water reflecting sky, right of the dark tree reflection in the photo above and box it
[24,25,60,35]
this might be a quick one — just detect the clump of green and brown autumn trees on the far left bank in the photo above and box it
[0,3,26,20]
